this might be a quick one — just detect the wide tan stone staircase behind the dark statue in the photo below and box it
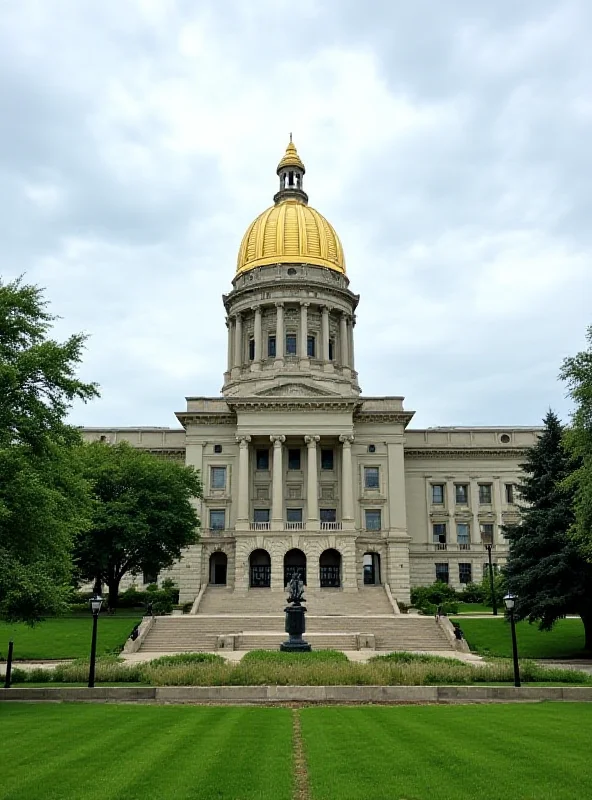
[135,586,452,653]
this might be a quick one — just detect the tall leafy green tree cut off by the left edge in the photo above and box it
[0,279,98,622]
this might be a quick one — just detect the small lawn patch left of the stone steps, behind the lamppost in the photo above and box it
[0,614,140,660]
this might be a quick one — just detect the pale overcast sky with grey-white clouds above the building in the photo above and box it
[0,0,592,427]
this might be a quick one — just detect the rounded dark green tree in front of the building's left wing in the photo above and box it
[76,442,201,609]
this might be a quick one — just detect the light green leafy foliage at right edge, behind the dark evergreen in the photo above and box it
[560,326,592,562]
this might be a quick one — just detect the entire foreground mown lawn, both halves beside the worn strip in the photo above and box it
[0,703,592,800]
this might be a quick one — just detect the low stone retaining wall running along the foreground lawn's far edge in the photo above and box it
[0,686,592,705]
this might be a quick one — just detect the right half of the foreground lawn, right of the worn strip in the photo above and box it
[300,703,592,800]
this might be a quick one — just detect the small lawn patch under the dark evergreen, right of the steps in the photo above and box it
[458,617,585,658]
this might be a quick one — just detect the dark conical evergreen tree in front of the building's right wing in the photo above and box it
[504,411,592,649]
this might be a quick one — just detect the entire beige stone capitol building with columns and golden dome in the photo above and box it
[83,141,538,607]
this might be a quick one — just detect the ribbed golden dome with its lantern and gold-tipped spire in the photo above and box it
[236,144,345,275]
